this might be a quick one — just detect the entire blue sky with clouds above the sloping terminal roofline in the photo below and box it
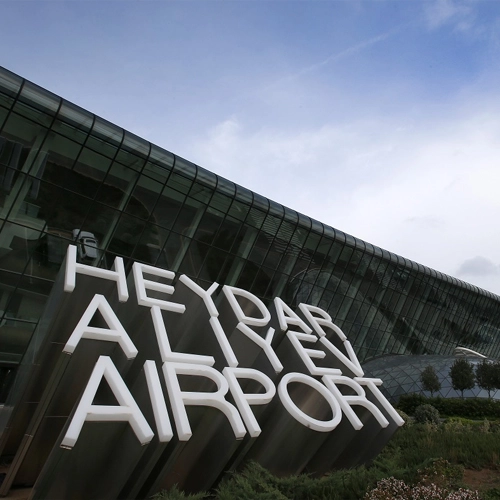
[0,0,500,294]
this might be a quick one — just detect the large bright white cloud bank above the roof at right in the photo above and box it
[190,95,500,294]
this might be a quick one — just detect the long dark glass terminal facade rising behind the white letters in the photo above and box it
[0,65,500,401]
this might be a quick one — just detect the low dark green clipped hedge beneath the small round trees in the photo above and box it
[397,394,500,419]
